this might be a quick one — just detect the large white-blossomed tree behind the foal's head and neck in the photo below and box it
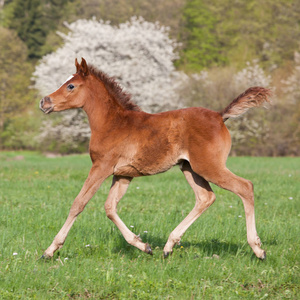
[33,17,183,151]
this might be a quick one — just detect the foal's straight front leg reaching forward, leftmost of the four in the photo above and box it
[42,165,111,258]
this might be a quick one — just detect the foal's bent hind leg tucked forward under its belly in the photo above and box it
[164,161,216,257]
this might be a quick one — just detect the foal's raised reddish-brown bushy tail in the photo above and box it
[220,86,271,122]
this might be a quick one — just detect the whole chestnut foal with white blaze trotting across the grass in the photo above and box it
[40,58,270,259]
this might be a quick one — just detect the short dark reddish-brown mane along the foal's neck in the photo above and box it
[88,65,141,111]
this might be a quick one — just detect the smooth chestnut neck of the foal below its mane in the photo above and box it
[83,79,124,134]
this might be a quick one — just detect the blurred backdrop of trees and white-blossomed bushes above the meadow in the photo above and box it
[0,0,300,156]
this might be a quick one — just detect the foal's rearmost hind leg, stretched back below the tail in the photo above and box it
[197,167,266,259]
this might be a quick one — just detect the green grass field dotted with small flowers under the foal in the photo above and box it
[0,152,300,299]
